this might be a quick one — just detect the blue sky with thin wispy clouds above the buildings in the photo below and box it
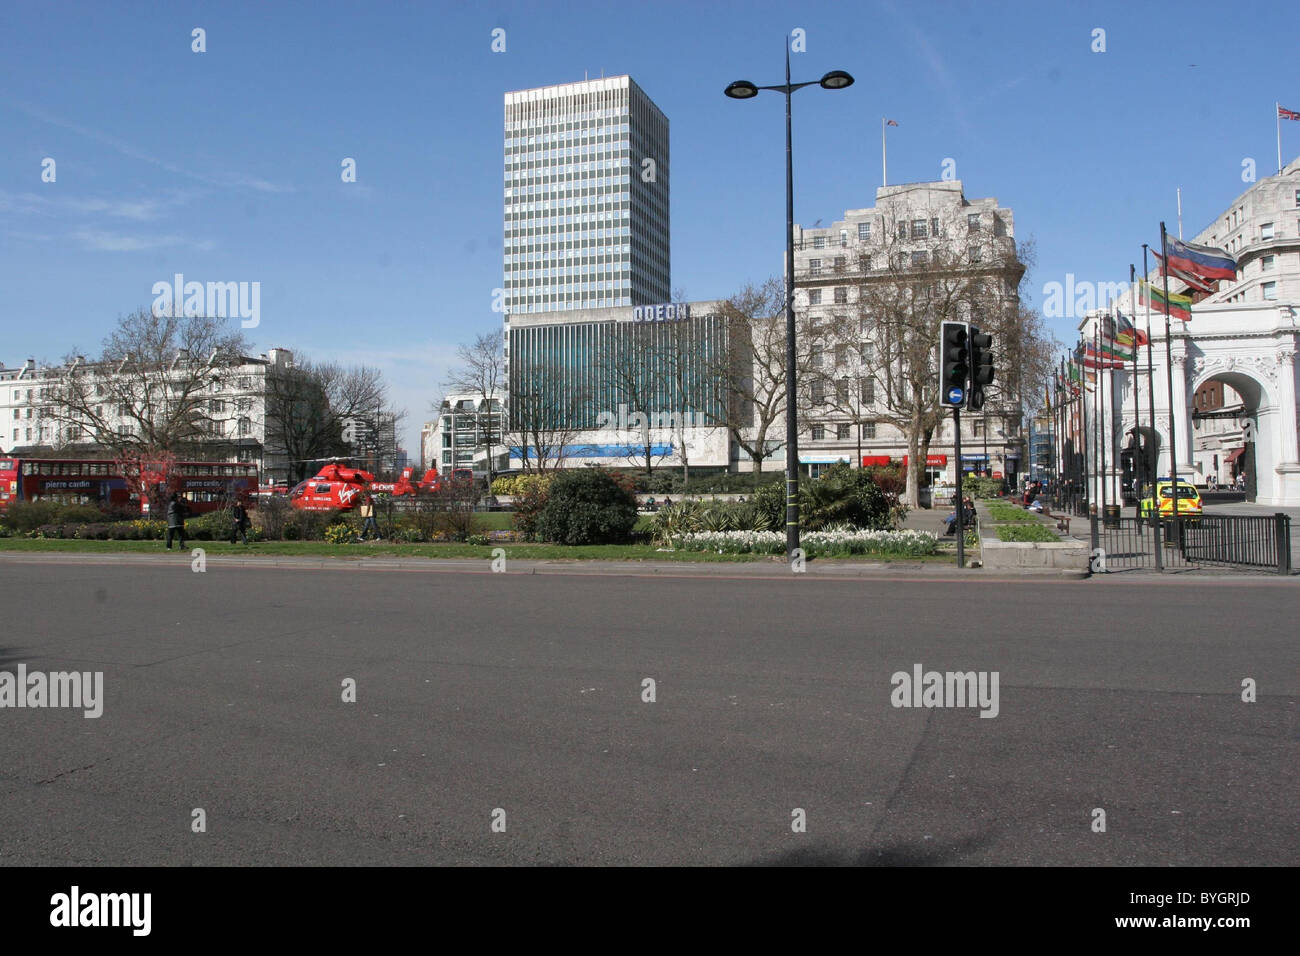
[0,0,1300,457]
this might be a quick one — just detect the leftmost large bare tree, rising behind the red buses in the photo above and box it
[40,310,248,457]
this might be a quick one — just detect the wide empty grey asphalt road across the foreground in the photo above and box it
[0,555,1300,865]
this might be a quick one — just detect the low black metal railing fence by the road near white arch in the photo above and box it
[1091,514,1292,575]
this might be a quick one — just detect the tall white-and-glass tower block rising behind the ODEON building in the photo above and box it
[503,75,671,315]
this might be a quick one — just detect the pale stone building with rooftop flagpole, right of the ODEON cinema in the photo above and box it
[790,179,1028,488]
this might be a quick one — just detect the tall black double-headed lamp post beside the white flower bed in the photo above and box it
[723,46,853,561]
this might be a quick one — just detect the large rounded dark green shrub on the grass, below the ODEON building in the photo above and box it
[534,468,637,545]
